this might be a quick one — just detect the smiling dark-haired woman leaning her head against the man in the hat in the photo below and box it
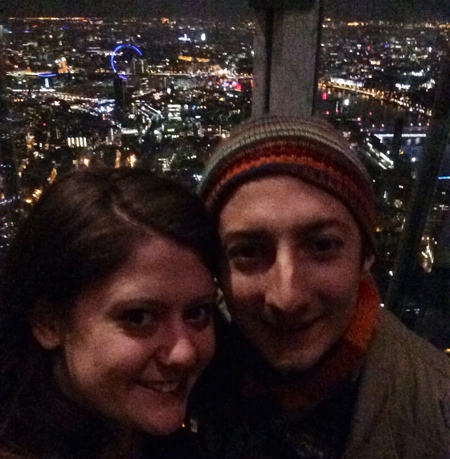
[0,169,217,459]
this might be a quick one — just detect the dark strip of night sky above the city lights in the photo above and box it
[0,0,450,21]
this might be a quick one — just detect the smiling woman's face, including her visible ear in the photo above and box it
[34,236,215,435]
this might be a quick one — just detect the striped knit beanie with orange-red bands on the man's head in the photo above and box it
[199,115,376,250]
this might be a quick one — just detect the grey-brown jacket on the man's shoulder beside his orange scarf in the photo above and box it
[344,312,450,459]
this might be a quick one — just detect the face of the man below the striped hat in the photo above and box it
[219,176,369,373]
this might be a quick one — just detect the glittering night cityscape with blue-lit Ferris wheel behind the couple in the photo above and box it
[0,0,450,344]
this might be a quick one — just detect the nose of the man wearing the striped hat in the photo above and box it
[265,247,312,314]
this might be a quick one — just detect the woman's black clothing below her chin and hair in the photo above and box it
[0,381,200,459]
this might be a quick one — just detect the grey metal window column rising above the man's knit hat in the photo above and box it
[250,0,322,117]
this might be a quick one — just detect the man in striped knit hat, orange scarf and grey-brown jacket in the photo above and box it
[197,116,450,459]
